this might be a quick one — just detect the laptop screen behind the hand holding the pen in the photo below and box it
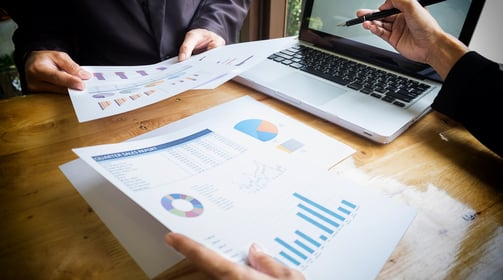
[299,0,485,79]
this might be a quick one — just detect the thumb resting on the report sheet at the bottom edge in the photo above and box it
[248,244,304,280]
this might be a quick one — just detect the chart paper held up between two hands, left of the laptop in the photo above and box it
[68,37,293,122]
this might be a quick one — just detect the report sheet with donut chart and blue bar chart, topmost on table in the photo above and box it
[74,122,415,279]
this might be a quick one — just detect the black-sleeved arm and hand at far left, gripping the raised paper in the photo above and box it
[7,0,84,93]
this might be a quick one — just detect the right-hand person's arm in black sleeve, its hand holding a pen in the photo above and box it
[357,0,503,156]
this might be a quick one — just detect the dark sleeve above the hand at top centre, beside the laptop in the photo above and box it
[190,0,251,44]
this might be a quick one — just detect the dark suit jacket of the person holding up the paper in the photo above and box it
[5,0,251,91]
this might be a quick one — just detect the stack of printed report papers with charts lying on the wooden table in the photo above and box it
[61,97,415,279]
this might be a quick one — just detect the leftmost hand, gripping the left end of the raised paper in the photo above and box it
[25,50,91,93]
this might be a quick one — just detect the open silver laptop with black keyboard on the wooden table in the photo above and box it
[234,0,485,144]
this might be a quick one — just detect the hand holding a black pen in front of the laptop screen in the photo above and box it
[356,0,468,79]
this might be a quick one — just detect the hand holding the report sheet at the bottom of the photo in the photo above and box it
[165,233,304,280]
